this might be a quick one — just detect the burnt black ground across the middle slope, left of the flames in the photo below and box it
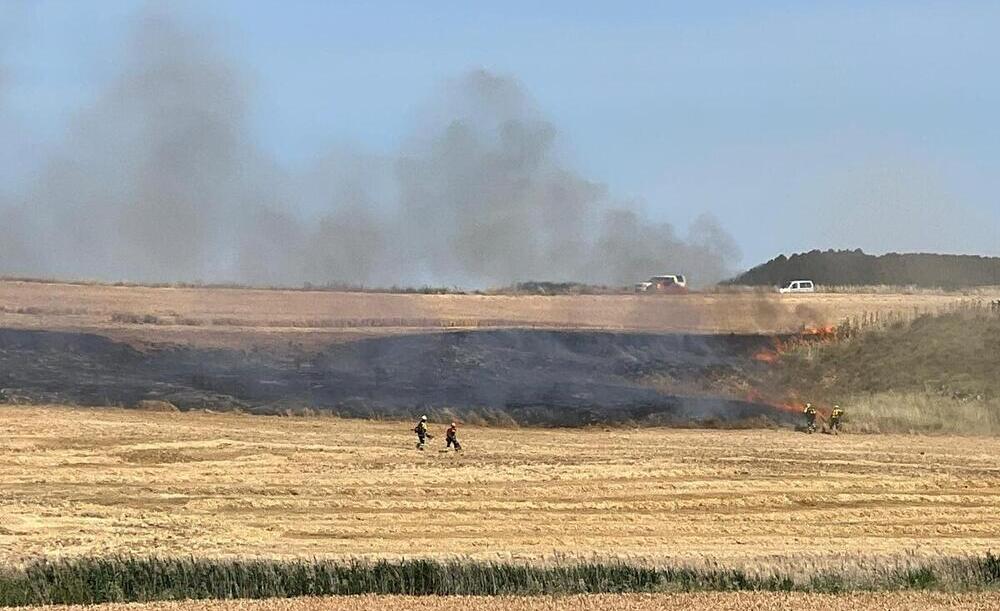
[0,329,788,426]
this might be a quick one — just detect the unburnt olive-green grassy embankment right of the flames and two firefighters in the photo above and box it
[779,304,1000,435]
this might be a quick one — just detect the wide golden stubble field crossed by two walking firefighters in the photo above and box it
[0,406,1000,564]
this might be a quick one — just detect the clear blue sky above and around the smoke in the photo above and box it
[0,0,1000,265]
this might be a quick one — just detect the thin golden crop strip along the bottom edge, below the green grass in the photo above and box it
[19,592,1000,611]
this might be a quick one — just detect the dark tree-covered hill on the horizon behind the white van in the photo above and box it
[729,249,1000,288]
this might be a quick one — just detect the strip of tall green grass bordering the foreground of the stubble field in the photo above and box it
[0,553,1000,607]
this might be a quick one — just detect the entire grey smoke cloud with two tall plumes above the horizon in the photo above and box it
[0,15,739,286]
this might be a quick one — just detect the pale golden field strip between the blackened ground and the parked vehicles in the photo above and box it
[0,281,993,345]
